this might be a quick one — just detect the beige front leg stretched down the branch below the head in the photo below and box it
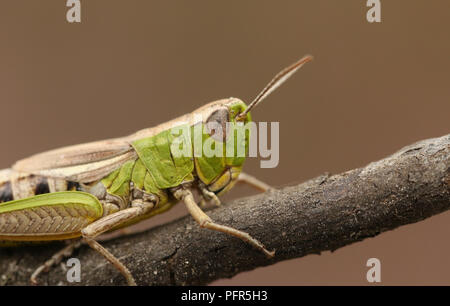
[173,189,275,258]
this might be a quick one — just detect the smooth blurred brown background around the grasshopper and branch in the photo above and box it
[0,0,450,285]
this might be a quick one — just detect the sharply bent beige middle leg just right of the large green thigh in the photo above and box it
[81,202,154,286]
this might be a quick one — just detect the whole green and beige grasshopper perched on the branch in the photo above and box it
[0,56,312,285]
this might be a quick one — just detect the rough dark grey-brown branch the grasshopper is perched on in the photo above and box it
[0,135,450,285]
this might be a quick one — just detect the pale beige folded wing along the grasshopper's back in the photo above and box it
[12,138,137,183]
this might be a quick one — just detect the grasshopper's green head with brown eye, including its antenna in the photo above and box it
[195,56,312,195]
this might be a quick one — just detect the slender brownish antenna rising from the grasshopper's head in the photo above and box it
[237,55,313,120]
